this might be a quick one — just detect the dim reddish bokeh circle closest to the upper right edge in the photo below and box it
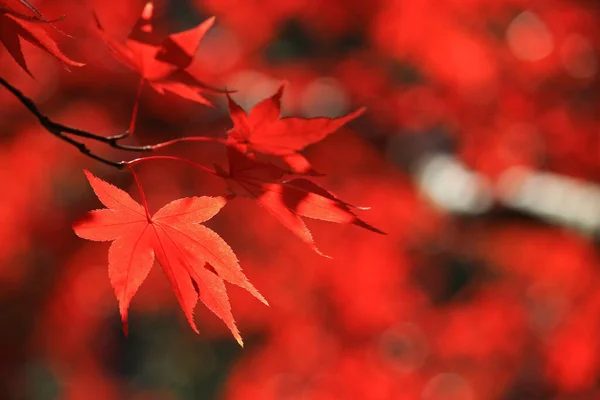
[560,34,598,79]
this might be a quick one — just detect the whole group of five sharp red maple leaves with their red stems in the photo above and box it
[2,1,383,345]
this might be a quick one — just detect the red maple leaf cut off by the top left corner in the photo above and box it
[0,0,84,75]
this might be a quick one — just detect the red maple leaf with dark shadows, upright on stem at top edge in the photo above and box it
[96,1,227,105]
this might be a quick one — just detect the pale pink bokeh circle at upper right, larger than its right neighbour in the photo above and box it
[506,11,554,61]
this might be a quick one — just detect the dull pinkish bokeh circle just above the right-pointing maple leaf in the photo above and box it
[301,78,349,117]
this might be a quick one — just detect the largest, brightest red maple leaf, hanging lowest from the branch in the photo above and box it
[73,171,267,345]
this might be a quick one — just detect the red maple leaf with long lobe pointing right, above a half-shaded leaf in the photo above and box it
[228,85,366,173]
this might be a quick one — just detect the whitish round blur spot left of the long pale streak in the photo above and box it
[417,154,492,214]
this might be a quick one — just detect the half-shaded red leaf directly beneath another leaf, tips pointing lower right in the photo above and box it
[217,142,383,257]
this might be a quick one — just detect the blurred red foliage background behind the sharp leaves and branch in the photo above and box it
[0,0,600,400]
